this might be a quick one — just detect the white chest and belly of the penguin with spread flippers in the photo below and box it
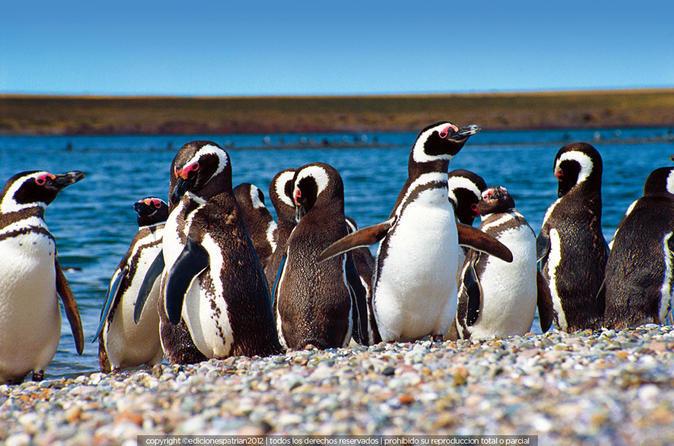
[374,188,459,341]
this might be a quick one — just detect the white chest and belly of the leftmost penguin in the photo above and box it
[0,232,61,382]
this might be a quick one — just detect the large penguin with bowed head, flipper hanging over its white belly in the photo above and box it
[135,141,281,358]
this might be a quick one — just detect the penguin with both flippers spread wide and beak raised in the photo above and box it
[320,122,512,342]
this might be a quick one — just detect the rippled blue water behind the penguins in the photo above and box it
[0,128,674,376]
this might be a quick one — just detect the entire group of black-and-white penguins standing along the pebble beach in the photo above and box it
[0,121,674,383]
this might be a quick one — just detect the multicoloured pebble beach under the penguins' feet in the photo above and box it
[0,325,674,445]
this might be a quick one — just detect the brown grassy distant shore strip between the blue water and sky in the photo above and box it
[0,89,674,135]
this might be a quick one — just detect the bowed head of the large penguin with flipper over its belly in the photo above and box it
[169,141,232,206]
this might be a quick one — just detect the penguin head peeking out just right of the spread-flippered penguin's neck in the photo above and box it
[447,169,487,225]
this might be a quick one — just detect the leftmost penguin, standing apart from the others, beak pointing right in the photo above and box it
[0,171,84,384]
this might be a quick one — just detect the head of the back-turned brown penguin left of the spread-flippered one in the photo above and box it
[293,163,344,222]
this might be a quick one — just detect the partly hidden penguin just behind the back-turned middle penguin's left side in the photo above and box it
[264,169,297,291]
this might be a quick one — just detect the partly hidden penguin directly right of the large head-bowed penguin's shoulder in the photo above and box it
[234,183,277,268]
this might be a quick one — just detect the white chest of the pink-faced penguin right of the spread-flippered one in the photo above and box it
[469,225,537,339]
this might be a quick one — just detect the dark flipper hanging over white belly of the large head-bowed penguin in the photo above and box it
[165,237,210,325]
